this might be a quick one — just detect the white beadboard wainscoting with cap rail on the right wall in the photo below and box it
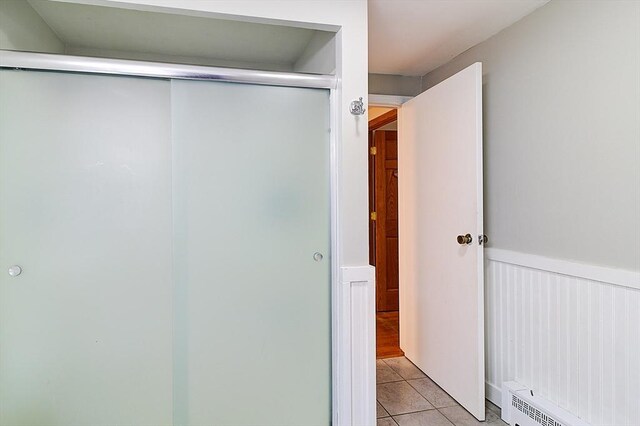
[485,249,640,426]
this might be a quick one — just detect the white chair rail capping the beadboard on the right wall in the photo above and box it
[485,248,640,290]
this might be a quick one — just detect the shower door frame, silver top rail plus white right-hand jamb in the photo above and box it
[0,49,353,425]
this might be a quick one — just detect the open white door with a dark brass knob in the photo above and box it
[398,63,485,420]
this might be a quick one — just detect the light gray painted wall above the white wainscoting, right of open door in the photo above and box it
[423,0,640,271]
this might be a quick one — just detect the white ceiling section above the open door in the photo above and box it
[369,0,549,76]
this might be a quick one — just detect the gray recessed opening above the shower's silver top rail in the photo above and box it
[0,0,335,74]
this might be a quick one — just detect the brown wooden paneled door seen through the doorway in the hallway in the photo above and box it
[370,130,398,312]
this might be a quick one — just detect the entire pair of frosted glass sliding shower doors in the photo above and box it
[0,70,331,426]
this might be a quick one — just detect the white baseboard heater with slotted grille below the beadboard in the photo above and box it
[501,382,590,426]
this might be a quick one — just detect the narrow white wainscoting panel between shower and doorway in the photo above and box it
[334,266,376,426]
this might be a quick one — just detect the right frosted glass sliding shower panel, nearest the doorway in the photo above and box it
[172,81,331,426]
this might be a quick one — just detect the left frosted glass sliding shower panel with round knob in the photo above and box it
[0,70,172,426]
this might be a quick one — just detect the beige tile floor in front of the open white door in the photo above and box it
[376,357,507,426]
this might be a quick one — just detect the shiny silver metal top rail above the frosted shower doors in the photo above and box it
[0,50,336,89]
